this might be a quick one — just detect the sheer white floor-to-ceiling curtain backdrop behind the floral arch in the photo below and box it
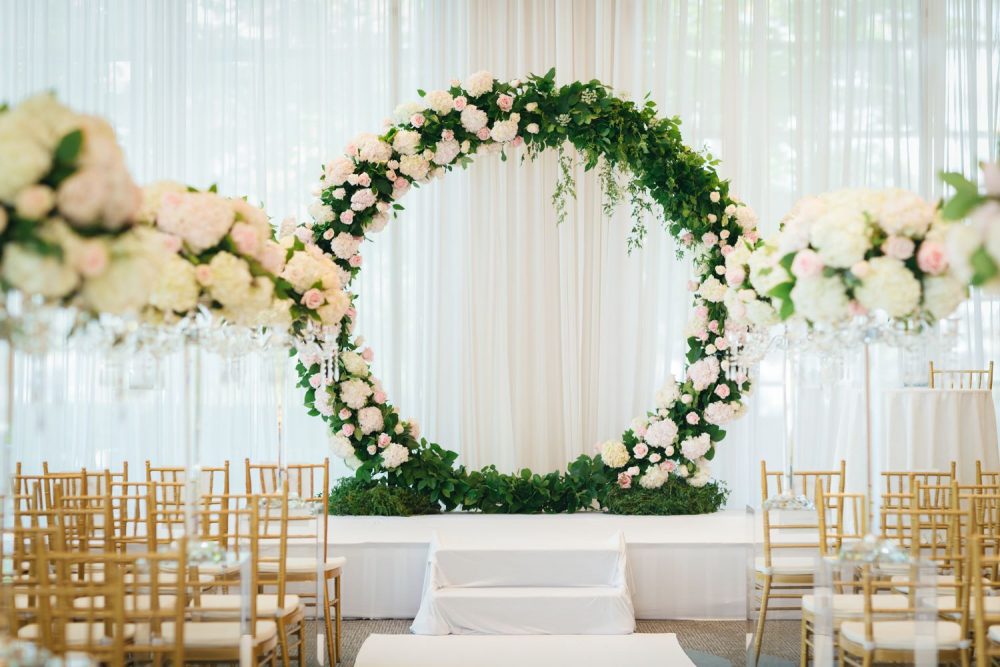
[0,0,1000,503]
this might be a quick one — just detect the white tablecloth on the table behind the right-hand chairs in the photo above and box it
[885,388,1000,484]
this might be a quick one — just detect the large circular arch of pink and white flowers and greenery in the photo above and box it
[295,70,760,513]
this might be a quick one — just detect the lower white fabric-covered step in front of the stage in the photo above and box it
[411,586,635,635]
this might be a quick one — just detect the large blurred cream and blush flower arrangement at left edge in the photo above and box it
[0,94,170,316]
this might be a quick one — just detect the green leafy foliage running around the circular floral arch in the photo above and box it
[298,70,756,515]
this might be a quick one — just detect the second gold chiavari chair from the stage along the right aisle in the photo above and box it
[799,485,907,667]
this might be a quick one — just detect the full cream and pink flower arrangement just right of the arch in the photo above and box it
[744,189,968,333]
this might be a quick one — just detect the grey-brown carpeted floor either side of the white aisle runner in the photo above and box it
[294,619,799,667]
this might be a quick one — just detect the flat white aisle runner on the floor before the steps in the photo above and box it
[354,634,694,667]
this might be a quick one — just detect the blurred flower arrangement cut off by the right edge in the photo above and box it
[941,163,1000,293]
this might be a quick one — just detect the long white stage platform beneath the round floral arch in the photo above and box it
[304,511,753,619]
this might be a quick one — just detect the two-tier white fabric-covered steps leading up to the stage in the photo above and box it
[410,533,635,635]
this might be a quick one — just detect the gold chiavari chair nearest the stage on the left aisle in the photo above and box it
[245,458,346,665]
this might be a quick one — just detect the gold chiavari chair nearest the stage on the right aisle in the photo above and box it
[754,461,846,662]
